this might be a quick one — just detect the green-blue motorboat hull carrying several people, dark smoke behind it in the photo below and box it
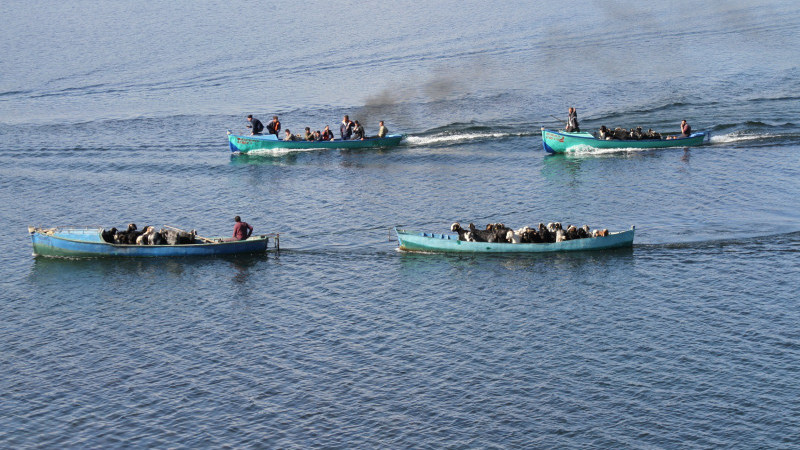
[228,131,404,154]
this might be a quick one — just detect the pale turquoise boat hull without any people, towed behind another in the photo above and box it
[394,226,636,253]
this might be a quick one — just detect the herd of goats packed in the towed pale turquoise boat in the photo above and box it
[450,222,608,244]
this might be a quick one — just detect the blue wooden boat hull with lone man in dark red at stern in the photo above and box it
[28,227,280,258]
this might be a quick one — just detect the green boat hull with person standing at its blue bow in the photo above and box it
[542,128,708,153]
